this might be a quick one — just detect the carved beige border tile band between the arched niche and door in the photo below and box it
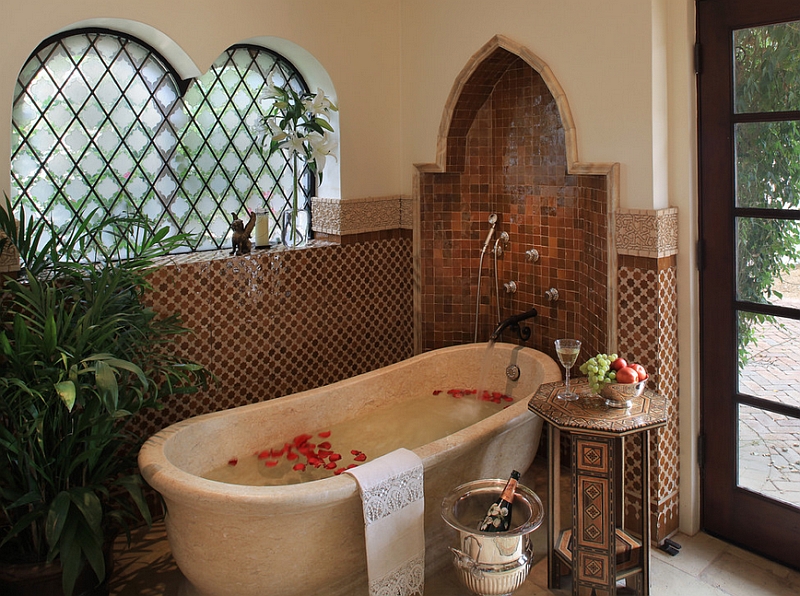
[615,207,678,258]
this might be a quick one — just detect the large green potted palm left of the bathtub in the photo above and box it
[0,199,209,596]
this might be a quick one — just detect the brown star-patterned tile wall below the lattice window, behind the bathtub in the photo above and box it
[130,237,413,435]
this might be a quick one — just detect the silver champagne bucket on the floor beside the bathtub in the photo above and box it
[442,479,544,596]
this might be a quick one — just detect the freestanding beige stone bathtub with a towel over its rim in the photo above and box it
[139,343,561,596]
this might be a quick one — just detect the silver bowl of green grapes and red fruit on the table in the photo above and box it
[580,354,649,408]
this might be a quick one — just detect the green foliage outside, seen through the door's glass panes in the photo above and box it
[734,22,800,369]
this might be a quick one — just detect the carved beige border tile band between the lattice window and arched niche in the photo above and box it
[311,197,411,236]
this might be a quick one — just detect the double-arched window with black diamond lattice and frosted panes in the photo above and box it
[11,30,315,259]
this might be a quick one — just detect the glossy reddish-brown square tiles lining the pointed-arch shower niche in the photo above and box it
[419,50,608,364]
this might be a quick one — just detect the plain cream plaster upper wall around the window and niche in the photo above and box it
[0,0,698,531]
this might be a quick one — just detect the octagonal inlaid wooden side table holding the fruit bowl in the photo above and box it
[528,378,667,596]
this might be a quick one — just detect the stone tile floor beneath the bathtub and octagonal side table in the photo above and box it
[111,458,800,596]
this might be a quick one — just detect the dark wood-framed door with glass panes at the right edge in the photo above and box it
[697,0,800,567]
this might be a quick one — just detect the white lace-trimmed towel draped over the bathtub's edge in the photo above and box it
[347,449,425,596]
